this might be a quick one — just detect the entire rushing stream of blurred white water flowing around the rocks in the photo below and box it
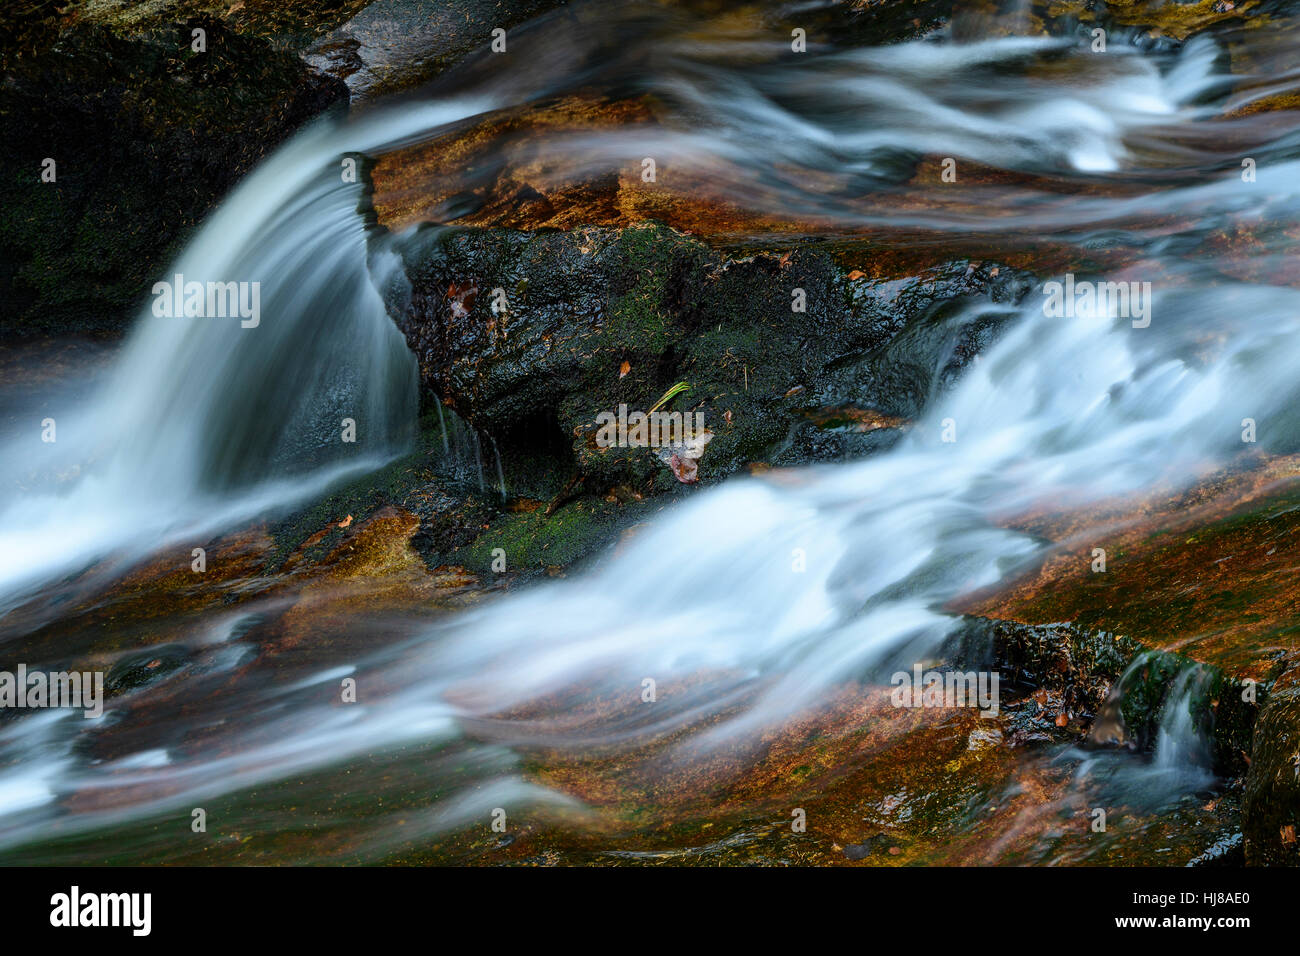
[0,1,1300,860]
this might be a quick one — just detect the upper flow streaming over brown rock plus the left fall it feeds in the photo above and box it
[0,13,1284,611]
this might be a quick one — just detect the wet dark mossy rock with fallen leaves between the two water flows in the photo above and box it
[387,225,1030,494]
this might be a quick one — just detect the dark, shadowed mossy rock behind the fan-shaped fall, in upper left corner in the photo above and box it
[0,17,347,337]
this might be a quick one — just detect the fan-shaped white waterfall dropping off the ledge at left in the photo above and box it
[0,100,501,615]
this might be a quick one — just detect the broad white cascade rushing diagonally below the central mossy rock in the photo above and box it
[400,277,1300,741]
